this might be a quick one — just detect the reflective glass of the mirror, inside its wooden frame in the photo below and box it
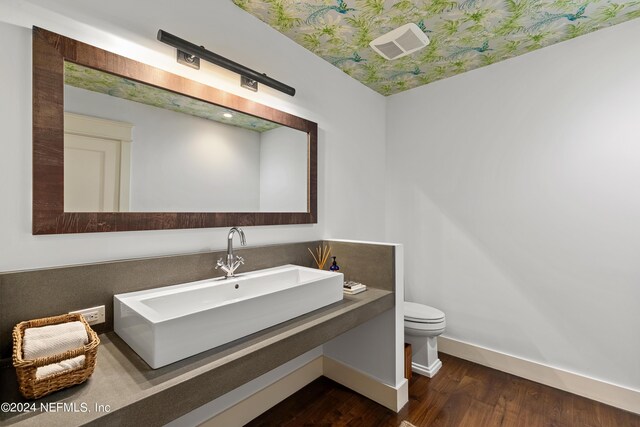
[64,61,309,212]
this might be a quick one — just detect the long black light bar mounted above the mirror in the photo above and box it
[158,30,296,96]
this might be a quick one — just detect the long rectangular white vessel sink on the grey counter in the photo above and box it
[113,265,344,369]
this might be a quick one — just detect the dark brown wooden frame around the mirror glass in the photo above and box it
[33,27,318,234]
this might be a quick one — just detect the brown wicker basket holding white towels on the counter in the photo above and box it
[13,314,100,399]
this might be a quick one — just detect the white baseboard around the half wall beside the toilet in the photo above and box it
[322,356,409,412]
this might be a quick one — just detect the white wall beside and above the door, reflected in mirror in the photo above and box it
[64,85,262,212]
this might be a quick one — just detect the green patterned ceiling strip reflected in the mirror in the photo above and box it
[64,61,281,132]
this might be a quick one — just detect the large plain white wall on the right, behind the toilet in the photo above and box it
[387,20,640,390]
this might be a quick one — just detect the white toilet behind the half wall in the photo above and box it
[404,301,445,378]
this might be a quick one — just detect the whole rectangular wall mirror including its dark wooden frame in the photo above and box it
[33,27,317,234]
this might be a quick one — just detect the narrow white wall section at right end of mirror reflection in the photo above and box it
[260,126,309,212]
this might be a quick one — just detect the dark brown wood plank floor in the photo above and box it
[248,354,640,427]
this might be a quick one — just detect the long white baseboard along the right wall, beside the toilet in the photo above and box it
[438,336,640,414]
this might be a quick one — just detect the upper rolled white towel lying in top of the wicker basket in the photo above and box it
[22,322,89,360]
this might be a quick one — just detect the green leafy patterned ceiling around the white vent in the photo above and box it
[233,0,640,95]
